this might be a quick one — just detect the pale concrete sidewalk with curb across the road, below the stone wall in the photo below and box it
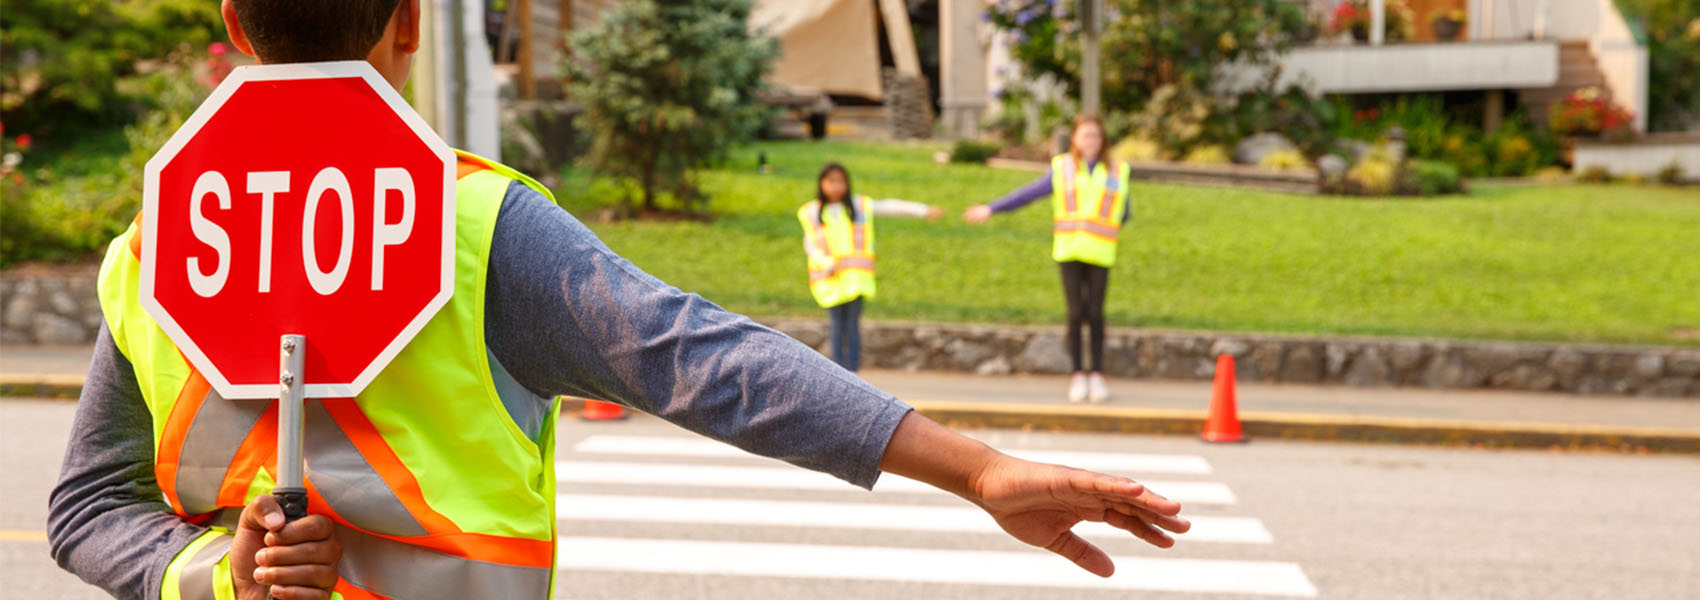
[13,345,1700,452]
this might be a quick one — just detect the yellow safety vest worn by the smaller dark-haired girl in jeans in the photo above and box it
[797,195,874,308]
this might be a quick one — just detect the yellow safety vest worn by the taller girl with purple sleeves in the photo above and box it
[1051,153,1131,269]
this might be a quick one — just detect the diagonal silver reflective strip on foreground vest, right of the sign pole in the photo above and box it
[301,399,428,535]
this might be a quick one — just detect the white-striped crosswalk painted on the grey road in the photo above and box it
[556,435,1318,597]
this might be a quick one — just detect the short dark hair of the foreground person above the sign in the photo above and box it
[231,0,401,63]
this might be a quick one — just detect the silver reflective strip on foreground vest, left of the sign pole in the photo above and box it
[177,388,270,515]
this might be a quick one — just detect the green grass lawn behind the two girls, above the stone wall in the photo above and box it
[578,141,1700,345]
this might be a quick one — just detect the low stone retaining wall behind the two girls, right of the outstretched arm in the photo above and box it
[763,320,1700,398]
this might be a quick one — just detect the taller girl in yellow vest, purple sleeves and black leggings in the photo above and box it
[962,114,1132,403]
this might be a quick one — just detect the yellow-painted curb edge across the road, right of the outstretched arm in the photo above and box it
[910,401,1700,454]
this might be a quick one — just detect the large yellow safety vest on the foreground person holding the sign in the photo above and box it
[99,149,559,600]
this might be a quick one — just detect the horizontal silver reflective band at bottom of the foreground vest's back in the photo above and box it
[337,527,554,600]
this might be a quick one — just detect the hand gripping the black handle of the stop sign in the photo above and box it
[230,495,342,600]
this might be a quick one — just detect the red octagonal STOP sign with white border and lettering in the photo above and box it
[141,61,454,398]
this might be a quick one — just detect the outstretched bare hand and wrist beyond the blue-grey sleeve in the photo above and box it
[879,411,1192,576]
